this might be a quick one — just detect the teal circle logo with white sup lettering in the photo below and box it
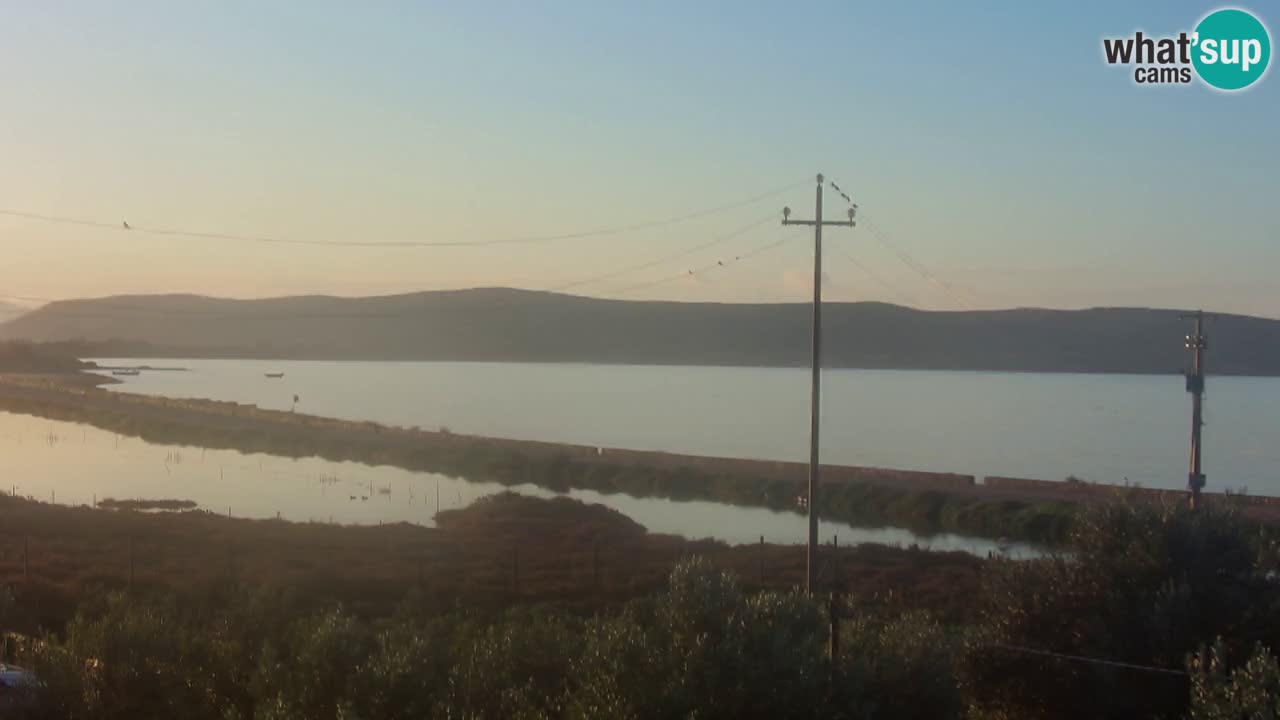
[1192,8,1271,90]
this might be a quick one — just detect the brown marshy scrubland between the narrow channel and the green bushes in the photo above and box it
[0,493,988,628]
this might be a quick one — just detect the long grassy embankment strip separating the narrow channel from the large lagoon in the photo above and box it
[0,373,1280,543]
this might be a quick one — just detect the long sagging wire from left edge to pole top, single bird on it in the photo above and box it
[0,181,804,247]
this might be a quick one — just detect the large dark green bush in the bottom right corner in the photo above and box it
[963,495,1280,719]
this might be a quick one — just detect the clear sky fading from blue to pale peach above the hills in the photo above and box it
[0,0,1280,318]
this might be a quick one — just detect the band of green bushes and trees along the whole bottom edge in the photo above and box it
[0,498,1280,720]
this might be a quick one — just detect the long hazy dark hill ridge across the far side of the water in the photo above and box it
[0,288,1280,375]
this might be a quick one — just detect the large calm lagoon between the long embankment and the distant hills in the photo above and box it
[92,360,1280,495]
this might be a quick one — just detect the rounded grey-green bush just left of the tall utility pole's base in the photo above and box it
[568,559,826,720]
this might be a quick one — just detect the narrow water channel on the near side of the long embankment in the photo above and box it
[0,413,1034,556]
